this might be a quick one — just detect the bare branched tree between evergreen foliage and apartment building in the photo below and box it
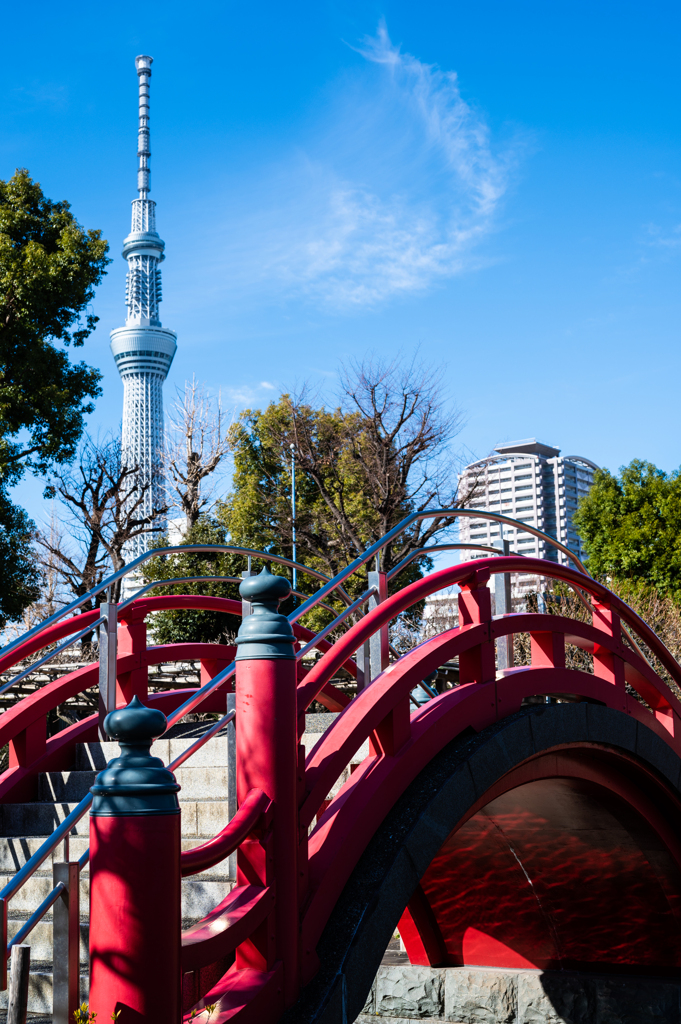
[289,357,475,569]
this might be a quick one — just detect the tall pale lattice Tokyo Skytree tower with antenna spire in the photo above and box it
[111,56,177,561]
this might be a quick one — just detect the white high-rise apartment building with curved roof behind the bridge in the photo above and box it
[459,437,598,594]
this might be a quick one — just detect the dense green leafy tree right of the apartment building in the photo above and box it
[574,459,681,602]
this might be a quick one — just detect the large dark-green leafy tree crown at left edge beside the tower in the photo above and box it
[0,170,110,478]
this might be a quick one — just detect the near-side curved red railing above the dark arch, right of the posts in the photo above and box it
[178,557,681,1006]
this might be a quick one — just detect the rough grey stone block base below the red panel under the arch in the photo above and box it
[356,965,681,1024]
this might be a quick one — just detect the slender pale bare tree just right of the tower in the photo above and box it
[164,378,229,532]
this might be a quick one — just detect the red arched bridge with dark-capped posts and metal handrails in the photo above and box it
[0,511,681,1024]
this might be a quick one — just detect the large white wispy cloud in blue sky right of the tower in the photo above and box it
[191,25,521,310]
